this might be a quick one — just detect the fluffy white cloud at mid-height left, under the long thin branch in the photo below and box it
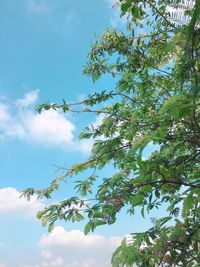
[0,90,92,153]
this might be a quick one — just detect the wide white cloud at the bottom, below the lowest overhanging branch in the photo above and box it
[39,226,122,267]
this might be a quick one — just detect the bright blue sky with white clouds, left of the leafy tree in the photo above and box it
[0,0,161,267]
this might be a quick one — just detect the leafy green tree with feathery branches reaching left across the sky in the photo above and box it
[23,0,200,267]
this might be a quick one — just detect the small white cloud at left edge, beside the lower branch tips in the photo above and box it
[0,187,44,218]
